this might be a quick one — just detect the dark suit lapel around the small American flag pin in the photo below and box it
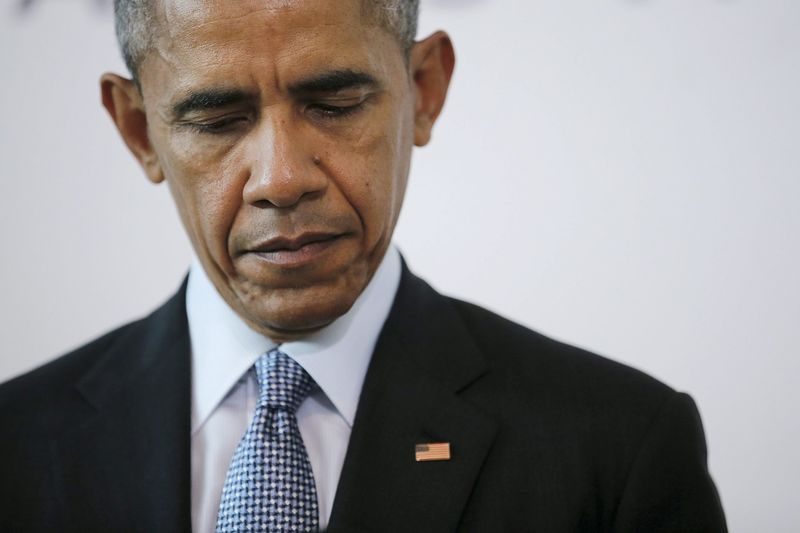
[329,268,497,532]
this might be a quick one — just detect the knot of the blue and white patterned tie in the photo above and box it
[256,348,317,413]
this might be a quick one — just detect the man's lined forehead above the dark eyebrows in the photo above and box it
[141,0,402,97]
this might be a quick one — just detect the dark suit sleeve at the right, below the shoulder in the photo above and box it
[613,393,727,533]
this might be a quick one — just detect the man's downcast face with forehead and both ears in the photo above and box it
[100,0,455,342]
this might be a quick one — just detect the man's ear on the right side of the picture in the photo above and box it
[410,31,456,146]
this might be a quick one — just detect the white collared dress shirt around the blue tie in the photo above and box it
[186,247,401,533]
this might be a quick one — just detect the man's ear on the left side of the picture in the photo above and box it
[100,73,164,183]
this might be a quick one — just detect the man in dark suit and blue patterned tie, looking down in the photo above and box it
[0,0,725,532]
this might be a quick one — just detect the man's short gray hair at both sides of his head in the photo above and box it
[114,0,419,83]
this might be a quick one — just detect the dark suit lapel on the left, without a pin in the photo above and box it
[53,284,191,531]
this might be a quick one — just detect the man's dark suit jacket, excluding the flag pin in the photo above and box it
[0,270,726,533]
